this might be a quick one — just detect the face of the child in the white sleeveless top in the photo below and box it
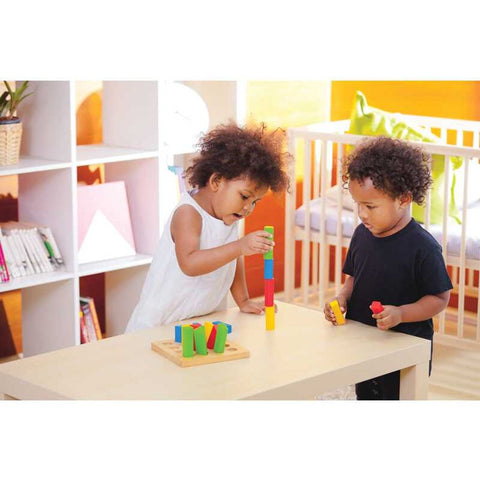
[212,177,268,225]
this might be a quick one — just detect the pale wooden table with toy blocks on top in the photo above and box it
[0,302,430,400]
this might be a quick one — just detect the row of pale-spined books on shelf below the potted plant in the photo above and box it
[0,222,64,282]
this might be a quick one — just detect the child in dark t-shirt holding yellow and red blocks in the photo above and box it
[324,137,453,400]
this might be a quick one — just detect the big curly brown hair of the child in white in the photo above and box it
[185,122,289,192]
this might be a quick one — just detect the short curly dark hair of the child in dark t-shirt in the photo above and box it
[343,137,432,205]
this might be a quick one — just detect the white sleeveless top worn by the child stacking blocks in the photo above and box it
[125,192,238,332]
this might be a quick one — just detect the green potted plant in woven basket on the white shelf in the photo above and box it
[0,80,31,165]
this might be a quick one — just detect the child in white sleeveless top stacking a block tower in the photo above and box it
[126,123,288,332]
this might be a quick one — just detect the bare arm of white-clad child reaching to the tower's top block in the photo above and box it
[170,205,274,276]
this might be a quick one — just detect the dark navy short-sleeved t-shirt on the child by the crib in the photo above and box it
[343,219,453,340]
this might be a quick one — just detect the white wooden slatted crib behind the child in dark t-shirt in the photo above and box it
[284,115,480,346]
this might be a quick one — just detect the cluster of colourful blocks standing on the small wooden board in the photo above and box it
[175,321,232,357]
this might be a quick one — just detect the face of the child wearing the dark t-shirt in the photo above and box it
[348,178,411,237]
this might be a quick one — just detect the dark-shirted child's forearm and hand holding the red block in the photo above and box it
[372,290,450,330]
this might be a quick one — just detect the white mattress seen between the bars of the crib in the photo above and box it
[295,198,480,260]
